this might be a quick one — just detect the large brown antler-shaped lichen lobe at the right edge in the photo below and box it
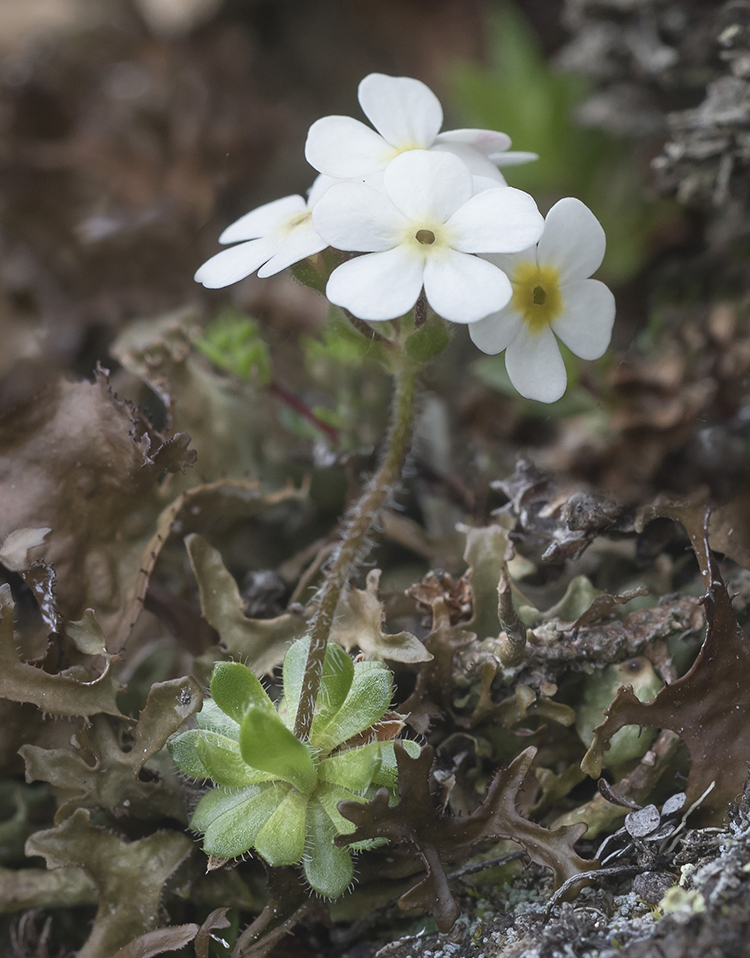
[582,507,750,821]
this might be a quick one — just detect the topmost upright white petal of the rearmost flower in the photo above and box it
[359,73,443,150]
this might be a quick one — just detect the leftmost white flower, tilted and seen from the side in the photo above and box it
[195,175,334,289]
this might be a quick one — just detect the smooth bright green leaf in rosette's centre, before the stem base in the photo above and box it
[240,708,318,794]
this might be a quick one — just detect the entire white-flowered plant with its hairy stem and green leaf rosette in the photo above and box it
[184,73,615,895]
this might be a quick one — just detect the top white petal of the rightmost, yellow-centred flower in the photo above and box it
[538,196,607,283]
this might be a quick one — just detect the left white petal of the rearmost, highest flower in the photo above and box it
[305,116,393,180]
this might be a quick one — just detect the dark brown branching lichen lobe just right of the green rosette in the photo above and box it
[337,746,597,931]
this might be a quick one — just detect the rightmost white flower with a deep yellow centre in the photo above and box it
[469,194,615,402]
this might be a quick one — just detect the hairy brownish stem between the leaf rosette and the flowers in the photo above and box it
[294,355,416,739]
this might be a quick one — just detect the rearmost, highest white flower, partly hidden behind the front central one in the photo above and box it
[305,73,537,184]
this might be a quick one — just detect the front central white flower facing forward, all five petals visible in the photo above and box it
[313,150,544,323]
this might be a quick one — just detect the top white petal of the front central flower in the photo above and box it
[384,150,474,223]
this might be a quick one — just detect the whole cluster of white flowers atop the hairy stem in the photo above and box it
[195,73,615,402]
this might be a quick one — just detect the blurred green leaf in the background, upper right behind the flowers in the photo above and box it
[452,3,676,282]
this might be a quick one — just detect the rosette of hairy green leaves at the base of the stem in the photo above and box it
[168,639,420,898]
